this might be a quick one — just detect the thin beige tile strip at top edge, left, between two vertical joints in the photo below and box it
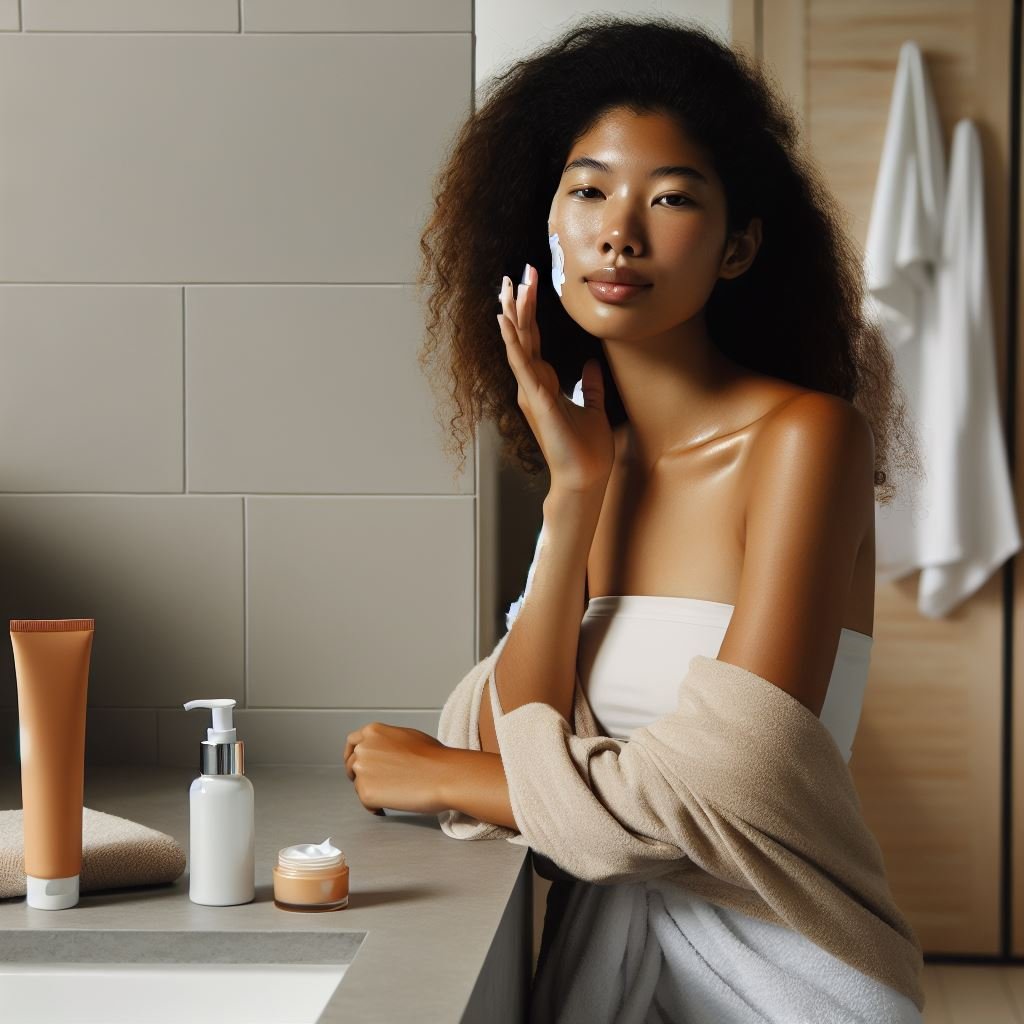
[22,0,240,32]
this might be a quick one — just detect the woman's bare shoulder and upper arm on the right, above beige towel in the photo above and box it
[717,392,874,717]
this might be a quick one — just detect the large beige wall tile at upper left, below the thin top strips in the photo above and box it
[0,33,472,283]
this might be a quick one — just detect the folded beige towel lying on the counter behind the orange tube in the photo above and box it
[0,807,185,898]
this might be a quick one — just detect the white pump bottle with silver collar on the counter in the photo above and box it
[184,697,256,906]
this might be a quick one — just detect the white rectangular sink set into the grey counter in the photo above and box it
[0,929,366,1024]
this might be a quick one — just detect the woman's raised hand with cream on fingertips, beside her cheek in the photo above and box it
[498,263,615,495]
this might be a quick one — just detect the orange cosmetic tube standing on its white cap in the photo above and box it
[10,618,95,910]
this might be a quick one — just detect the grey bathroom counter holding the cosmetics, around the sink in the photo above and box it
[0,765,532,1024]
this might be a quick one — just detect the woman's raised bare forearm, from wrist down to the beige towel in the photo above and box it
[480,488,604,754]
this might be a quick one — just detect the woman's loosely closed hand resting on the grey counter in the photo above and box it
[344,722,449,814]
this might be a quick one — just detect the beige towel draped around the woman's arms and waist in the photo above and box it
[437,633,925,1010]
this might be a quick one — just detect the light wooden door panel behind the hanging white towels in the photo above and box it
[734,0,1012,954]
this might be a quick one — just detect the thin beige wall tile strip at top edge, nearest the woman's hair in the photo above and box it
[242,0,473,32]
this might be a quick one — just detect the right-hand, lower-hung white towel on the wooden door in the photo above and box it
[918,118,1021,618]
